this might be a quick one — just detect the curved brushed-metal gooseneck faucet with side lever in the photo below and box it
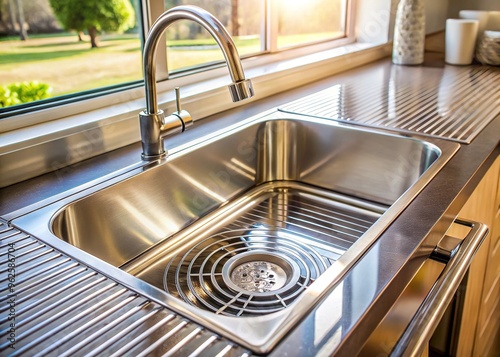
[139,6,254,160]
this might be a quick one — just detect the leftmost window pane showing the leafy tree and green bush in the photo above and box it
[0,0,142,107]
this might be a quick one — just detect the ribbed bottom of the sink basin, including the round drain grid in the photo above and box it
[124,183,383,316]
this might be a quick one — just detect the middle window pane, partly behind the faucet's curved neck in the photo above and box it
[164,0,265,72]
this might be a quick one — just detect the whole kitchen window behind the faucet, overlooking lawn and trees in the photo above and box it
[0,0,348,114]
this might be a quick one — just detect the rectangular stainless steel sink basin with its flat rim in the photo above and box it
[14,112,459,353]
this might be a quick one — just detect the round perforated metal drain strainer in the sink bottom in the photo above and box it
[222,251,300,296]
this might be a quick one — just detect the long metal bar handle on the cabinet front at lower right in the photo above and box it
[391,219,488,357]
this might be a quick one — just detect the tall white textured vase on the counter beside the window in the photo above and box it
[392,0,425,65]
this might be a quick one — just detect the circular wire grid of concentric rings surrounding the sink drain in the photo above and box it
[163,229,329,316]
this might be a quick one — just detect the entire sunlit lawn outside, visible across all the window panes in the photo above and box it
[0,34,338,96]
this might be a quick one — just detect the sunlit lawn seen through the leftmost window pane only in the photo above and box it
[0,35,142,96]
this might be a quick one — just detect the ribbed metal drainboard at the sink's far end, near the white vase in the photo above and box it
[280,66,500,143]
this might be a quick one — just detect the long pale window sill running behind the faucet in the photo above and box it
[0,43,391,187]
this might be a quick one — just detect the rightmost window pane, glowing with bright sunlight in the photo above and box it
[278,0,346,48]
